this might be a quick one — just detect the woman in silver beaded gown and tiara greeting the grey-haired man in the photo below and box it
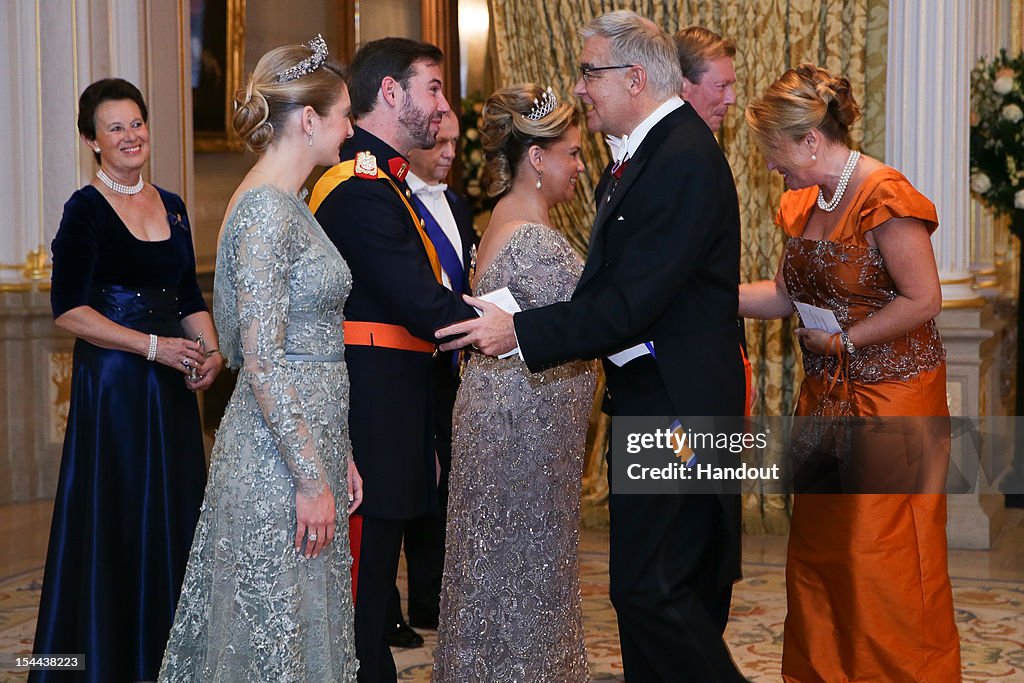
[433,84,595,683]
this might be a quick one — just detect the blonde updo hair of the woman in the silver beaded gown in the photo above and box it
[480,83,579,197]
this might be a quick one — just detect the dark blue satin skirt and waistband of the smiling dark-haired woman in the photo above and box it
[29,286,206,683]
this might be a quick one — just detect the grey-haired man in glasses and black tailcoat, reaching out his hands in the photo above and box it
[437,11,744,683]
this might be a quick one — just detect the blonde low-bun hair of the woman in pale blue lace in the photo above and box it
[231,45,345,154]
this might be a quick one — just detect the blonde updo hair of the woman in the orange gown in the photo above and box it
[745,63,860,150]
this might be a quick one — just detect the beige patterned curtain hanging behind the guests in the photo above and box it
[489,0,888,532]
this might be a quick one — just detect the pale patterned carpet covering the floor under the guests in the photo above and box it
[0,551,1024,683]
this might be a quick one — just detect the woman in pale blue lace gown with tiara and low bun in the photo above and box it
[160,39,361,683]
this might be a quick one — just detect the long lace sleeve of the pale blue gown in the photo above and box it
[237,189,327,496]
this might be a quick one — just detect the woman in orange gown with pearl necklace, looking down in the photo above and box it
[739,65,961,683]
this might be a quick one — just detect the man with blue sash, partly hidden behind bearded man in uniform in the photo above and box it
[389,112,478,647]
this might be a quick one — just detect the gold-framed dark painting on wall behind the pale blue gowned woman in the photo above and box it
[190,0,246,152]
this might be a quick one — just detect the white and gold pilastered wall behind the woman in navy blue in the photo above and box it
[0,0,193,504]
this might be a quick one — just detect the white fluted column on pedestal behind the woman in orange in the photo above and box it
[886,0,1006,548]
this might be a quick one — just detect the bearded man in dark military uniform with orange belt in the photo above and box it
[310,38,475,683]
